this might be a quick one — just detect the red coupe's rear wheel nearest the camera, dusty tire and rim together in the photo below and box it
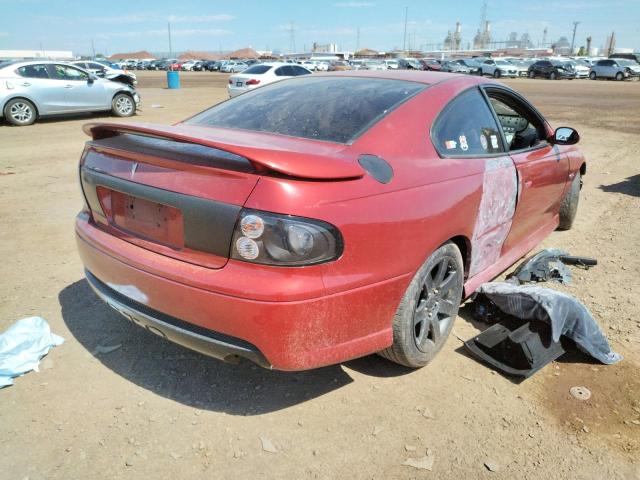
[379,242,464,368]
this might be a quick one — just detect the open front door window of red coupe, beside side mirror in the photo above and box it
[487,91,546,152]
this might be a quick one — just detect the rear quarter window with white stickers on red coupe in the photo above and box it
[432,88,504,156]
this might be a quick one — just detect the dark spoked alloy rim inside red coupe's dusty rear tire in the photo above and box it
[413,256,460,352]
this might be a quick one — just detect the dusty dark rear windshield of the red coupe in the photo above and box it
[186,77,426,143]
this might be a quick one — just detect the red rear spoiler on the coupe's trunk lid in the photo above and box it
[82,123,365,180]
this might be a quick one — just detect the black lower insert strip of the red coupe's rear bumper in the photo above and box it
[85,270,272,369]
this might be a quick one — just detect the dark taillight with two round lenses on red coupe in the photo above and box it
[231,209,342,267]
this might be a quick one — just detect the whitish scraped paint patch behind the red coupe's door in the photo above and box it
[469,157,518,277]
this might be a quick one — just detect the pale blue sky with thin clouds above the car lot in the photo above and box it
[0,0,640,55]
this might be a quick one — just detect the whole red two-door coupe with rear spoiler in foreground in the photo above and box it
[76,71,585,370]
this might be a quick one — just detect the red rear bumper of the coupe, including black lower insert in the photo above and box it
[76,214,404,370]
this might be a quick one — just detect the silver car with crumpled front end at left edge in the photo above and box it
[0,61,140,126]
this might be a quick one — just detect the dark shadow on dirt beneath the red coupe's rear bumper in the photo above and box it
[58,279,412,416]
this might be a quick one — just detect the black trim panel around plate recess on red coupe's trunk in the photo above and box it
[80,167,242,258]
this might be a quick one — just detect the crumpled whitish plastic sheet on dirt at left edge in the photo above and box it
[0,317,64,388]
